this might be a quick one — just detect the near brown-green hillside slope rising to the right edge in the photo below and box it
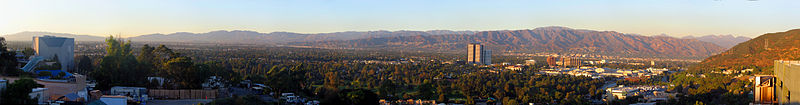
[694,29,800,69]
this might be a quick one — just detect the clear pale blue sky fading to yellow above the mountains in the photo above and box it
[0,0,800,37]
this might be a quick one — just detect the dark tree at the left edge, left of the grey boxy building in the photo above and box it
[0,37,19,75]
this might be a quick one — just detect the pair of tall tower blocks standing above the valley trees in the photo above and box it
[467,43,492,65]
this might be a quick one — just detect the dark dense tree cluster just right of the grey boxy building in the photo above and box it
[92,37,231,89]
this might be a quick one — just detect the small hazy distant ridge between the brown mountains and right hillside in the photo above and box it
[683,35,752,48]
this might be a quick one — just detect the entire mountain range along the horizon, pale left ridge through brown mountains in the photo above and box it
[2,26,738,59]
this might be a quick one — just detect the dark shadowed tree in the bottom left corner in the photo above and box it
[0,78,43,105]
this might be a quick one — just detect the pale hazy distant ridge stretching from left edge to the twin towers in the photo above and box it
[0,30,475,44]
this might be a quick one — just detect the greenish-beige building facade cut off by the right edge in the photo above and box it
[773,60,800,105]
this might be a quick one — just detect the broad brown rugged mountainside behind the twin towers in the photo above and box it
[291,27,724,59]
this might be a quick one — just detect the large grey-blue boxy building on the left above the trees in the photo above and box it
[32,35,75,71]
